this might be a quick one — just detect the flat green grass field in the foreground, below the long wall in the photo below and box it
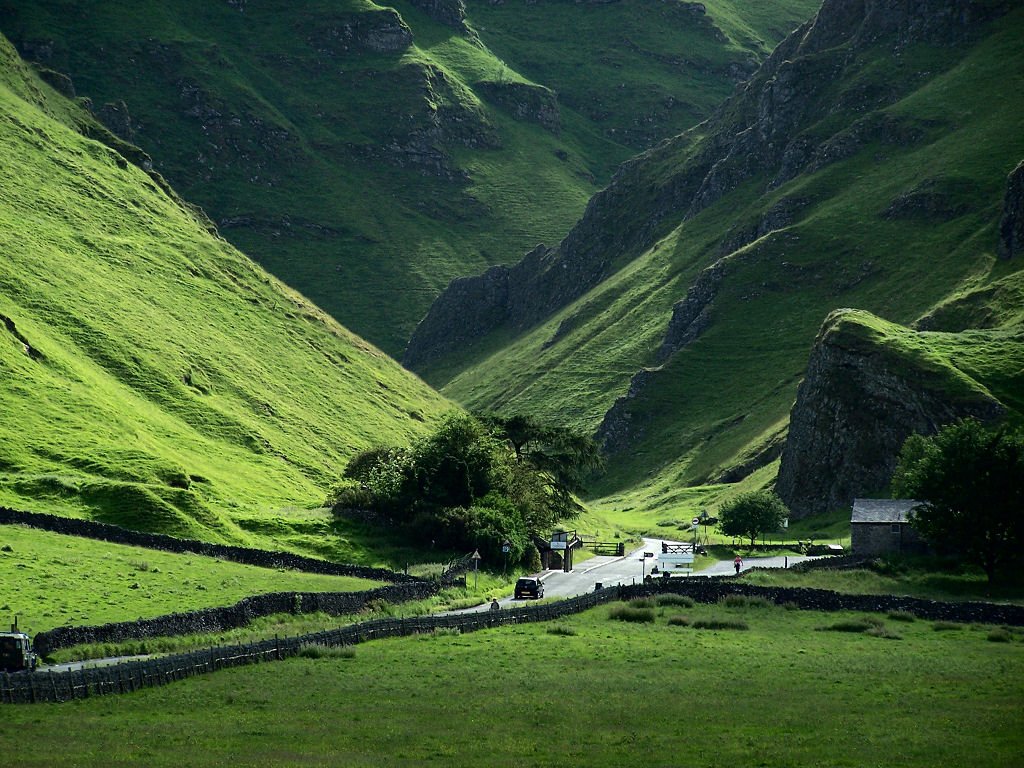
[0,606,1024,768]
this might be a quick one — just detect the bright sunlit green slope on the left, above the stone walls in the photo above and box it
[0,38,451,541]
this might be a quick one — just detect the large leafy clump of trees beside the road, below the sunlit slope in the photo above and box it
[333,414,600,560]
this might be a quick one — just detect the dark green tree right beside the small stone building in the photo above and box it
[892,419,1024,584]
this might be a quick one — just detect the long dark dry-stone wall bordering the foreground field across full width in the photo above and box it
[0,578,1024,703]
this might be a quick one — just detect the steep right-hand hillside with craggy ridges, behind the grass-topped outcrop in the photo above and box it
[418,1,1024,512]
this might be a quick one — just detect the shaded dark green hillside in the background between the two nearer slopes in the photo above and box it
[0,0,816,355]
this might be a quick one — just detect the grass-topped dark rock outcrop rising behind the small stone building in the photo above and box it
[775,309,1005,519]
